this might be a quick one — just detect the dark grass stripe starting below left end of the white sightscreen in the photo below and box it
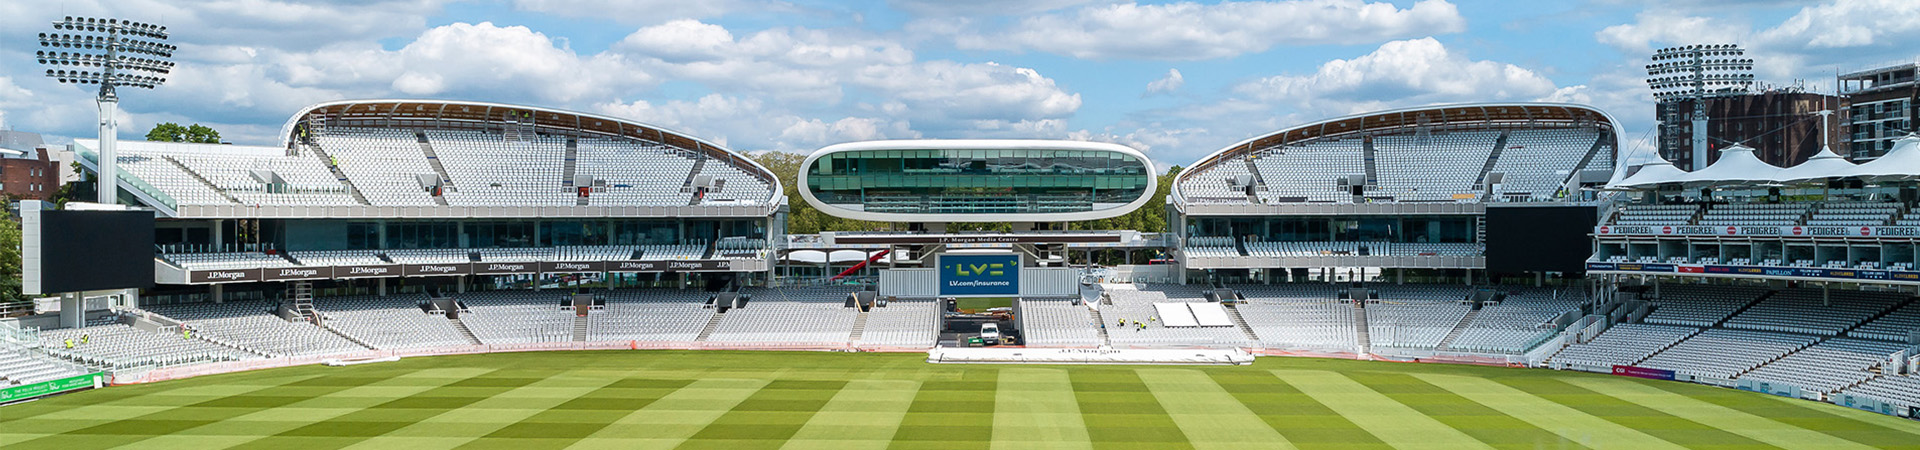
[887,369,1000,450]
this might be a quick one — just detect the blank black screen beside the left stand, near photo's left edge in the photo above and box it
[23,212,154,294]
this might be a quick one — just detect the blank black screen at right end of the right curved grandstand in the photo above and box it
[1486,206,1597,273]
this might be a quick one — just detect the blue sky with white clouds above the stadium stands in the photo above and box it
[0,0,1920,165]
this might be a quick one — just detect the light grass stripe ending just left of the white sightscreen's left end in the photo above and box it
[781,379,920,450]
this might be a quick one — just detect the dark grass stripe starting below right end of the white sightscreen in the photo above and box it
[1208,369,1392,450]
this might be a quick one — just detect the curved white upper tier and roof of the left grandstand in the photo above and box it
[81,100,785,217]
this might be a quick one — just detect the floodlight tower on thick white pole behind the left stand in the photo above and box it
[33,15,177,204]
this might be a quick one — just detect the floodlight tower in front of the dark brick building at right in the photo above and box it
[1647,44,1753,169]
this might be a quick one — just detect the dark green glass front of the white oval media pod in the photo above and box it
[804,148,1154,213]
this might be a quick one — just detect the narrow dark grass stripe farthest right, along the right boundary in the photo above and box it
[1649,376,1920,450]
